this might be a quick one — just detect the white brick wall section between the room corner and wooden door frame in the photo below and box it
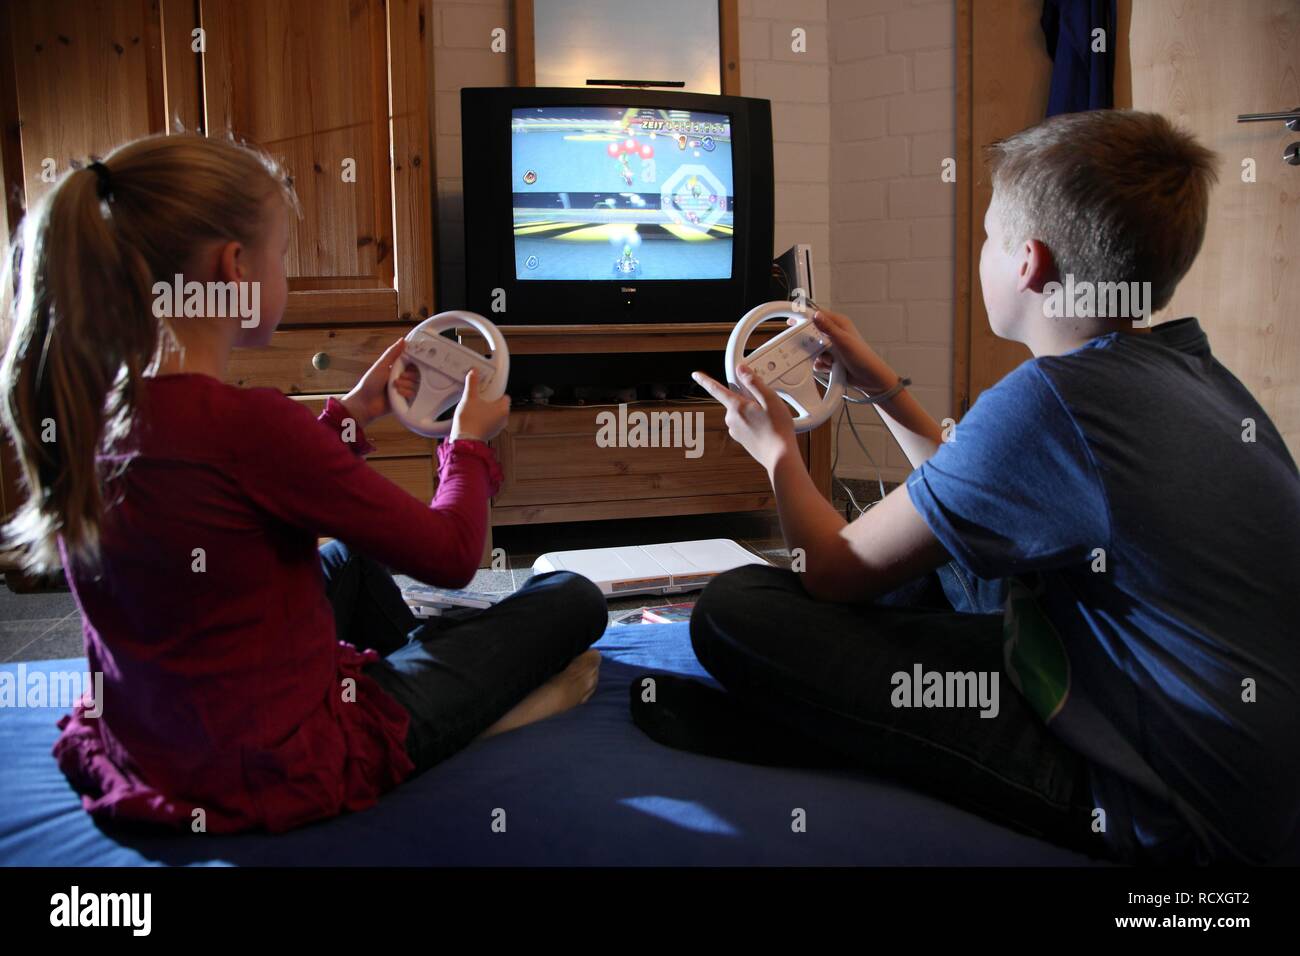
[821,0,957,481]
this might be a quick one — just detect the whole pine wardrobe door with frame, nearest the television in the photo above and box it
[199,0,433,325]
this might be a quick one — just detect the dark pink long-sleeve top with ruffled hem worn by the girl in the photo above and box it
[53,375,501,832]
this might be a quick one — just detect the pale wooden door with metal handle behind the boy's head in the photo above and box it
[1128,0,1300,458]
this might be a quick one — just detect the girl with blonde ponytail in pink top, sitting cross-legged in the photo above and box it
[0,134,606,831]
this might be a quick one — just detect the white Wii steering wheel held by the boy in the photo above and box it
[724,299,844,432]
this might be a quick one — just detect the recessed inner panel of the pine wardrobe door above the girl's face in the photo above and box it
[200,0,393,297]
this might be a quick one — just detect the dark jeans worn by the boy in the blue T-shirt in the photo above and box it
[690,564,1108,856]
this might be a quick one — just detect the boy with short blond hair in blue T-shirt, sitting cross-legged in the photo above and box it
[644,111,1300,862]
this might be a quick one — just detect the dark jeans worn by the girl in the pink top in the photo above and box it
[321,541,607,773]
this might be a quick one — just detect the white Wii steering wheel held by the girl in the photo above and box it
[389,311,510,438]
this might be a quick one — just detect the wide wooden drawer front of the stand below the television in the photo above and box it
[493,402,806,507]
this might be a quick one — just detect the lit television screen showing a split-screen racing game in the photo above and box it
[511,105,736,281]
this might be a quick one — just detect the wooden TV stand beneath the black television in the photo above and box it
[460,323,833,551]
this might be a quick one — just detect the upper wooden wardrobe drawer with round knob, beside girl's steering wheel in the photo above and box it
[226,324,411,394]
